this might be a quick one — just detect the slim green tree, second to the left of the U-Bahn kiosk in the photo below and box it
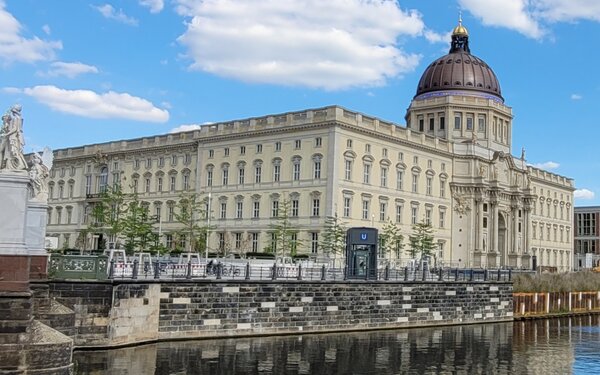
[265,200,302,257]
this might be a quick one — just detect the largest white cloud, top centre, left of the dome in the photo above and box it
[176,0,424,90]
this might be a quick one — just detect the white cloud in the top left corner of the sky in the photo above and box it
[0,0,62,64]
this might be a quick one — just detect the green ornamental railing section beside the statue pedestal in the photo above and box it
[48,254,108,280]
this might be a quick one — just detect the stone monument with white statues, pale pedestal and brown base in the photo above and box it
[0,105,73,374]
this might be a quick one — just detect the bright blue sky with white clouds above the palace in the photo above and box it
[0,0,600,206]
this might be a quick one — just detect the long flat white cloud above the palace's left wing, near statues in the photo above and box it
[4,86,169,122]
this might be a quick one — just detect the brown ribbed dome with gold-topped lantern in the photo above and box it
[415,21,504,101]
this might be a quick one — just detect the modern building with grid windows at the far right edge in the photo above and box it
[573,206,600,270]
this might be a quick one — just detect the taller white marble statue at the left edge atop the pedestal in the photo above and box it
[0,105,27,171]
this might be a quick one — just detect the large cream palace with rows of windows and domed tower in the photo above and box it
[48,19,574,270]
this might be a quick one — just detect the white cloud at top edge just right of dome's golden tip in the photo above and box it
[459,0,544,39]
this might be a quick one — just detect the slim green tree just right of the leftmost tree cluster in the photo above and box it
[174,193,210,253]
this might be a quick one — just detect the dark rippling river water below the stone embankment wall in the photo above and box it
[73,315,600,375]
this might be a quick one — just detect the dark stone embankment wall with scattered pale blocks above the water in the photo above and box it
[43,281,513,346]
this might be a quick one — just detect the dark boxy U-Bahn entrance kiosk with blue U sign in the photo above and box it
[346,227,378,280]
